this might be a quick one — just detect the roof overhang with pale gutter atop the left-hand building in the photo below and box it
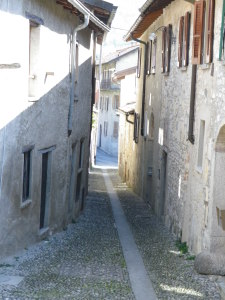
[56,0,110,42]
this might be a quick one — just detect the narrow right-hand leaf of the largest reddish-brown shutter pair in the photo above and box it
[206,0,215,63]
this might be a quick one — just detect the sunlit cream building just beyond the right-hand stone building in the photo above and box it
[113,45,139,186]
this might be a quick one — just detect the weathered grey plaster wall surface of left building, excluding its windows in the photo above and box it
[0,0,92,256]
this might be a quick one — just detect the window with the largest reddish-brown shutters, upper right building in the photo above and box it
[192,0,215,65]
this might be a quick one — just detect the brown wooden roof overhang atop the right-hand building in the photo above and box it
[124,0,174,42]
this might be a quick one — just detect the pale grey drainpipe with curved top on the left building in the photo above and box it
[68,14,89,136]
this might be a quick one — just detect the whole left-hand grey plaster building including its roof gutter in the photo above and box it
[0,0,109,256]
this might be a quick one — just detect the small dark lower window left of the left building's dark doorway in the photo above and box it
[22,149,32,202]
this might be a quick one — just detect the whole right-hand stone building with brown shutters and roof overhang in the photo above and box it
[123,0,225,272]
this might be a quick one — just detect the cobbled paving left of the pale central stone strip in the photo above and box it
[0,171,134,299]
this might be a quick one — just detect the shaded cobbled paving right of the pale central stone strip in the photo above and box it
[111,172,221,300]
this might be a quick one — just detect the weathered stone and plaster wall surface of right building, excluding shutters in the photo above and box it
[121,0,225,253]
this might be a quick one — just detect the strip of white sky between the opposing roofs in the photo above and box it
[103,0,146,56]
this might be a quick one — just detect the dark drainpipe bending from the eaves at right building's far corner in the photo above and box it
[131,34,148,136]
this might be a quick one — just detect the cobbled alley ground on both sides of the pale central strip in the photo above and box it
[0,152,220,300]
